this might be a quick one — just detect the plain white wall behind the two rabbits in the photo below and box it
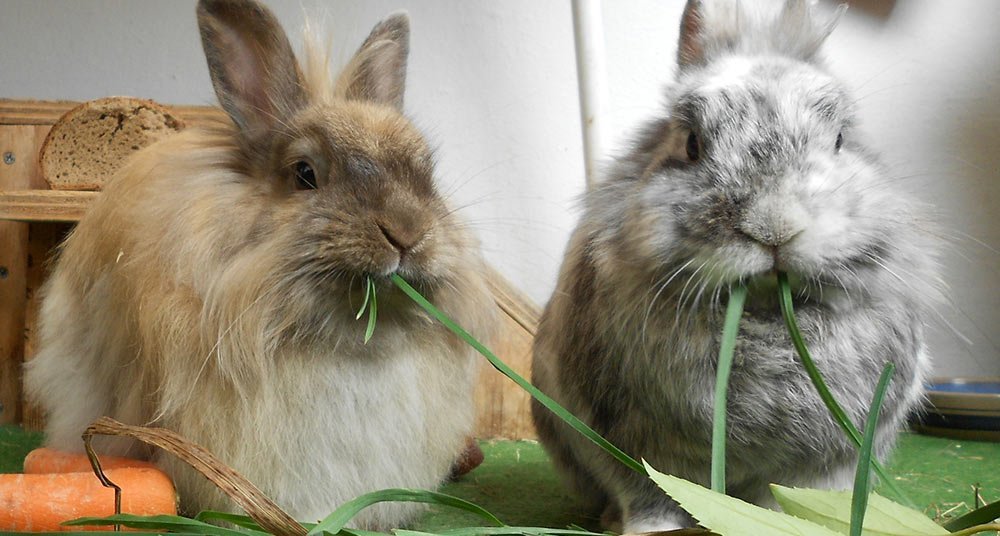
[0,0,1000,375]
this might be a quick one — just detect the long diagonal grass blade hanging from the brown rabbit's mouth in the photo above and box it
[392,274,646,474]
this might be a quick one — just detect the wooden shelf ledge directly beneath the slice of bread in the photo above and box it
[0,190,100,222]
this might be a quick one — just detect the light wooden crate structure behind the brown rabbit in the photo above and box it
[0,100,539,438]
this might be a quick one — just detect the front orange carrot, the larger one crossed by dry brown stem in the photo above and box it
[0,467,177,532]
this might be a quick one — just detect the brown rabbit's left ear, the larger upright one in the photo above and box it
[198,0,306,146]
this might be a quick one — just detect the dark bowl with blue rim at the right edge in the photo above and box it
[916,377,1000,442]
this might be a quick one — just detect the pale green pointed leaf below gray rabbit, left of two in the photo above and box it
[644,462,841,536]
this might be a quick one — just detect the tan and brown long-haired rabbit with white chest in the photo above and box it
[26,0,495,529]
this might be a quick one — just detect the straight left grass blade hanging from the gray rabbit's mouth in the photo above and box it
[712,285,747,493]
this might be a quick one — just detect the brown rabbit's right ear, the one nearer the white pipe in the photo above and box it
[335,13,410,110]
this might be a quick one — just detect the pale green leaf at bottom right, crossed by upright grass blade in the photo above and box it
[771,484,948,536]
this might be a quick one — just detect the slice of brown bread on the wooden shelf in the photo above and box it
[39,97,184,190]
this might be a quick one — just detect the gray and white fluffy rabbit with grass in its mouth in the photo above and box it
[532,0,938,532]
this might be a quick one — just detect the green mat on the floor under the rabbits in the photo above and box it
[0,426,1000,530]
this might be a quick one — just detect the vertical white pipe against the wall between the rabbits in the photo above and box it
[573,0,608,189]
